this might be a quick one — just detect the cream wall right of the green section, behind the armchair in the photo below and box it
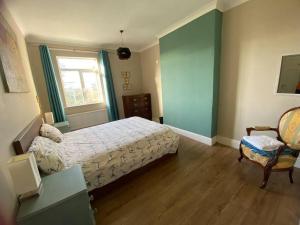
[218,0,300,140]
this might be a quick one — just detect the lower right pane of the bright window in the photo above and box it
[82,72,102,104]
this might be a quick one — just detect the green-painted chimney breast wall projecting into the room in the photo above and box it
[159,10,222,137]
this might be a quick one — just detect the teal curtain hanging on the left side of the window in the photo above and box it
[39,45,66,123]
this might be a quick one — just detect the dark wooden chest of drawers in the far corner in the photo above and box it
[122,94,152,120]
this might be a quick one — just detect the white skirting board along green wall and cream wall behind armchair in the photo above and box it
[167,125,300,168]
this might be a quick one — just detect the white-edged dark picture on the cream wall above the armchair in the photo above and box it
[277,55,300,94]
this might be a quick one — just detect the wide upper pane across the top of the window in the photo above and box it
[57,57,98,70]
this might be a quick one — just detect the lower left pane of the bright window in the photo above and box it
[61,71,84,107]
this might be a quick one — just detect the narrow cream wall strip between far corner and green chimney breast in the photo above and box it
[140,44,163,121]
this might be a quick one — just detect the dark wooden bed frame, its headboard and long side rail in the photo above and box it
[13,115,178,196]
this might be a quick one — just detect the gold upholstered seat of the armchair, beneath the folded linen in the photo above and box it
[242,144,299,169]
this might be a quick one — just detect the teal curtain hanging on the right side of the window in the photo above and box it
[99,50,119,121]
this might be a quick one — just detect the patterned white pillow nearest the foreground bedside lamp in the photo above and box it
[28,136,65,174]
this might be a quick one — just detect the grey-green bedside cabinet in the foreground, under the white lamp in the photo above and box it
[17,165,95,225]
